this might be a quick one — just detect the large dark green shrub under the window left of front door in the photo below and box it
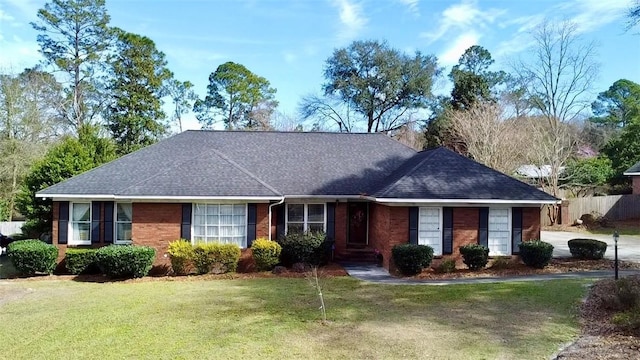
[277,232,333,267]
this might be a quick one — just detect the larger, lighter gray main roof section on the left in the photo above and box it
[40,131,415,197]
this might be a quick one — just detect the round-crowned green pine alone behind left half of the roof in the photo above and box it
[193,62,278,130]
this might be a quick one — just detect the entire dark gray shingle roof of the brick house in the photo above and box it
[39,131,555,201]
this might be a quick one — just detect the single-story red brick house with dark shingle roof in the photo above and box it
[36,131,558,267]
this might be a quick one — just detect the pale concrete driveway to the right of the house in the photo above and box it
[540,231,640,262]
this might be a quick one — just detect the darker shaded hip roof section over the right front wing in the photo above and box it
[374,148,556,201]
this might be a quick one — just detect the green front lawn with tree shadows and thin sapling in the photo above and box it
[0,277,586,359]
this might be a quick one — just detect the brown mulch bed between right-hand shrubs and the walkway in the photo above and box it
[414,258,640,280]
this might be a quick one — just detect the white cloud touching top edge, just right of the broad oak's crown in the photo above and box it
[421,0,506,44]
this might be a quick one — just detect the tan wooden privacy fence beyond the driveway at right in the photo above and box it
[540,194,640,225]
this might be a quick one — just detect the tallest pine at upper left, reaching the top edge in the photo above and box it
[31,0,110,128]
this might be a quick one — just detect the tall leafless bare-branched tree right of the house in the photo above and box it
[514,21,598,223]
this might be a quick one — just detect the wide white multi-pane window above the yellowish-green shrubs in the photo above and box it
[192,204,247,248]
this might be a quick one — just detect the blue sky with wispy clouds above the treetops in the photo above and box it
[0,0,640,128]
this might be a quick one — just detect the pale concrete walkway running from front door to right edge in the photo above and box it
[342,264,640,285]
